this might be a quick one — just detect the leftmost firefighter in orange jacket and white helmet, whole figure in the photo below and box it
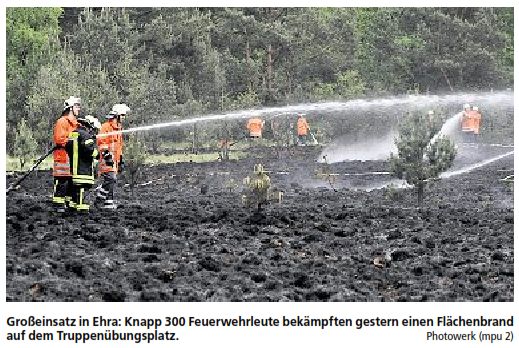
[52,96,81,213]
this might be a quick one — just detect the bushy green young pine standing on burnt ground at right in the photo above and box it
[390,113,457,204]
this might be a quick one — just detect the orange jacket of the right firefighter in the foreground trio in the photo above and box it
[97,119,123,173]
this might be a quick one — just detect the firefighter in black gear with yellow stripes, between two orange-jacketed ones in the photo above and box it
[65,115,101,212]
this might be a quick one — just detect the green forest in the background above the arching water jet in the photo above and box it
[6,7,513,154]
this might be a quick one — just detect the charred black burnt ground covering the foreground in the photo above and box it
[6,148,514,302]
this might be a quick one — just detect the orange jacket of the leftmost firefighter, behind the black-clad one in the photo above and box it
[52,115,78,177]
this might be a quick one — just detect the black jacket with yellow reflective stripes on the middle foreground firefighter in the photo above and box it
[65,126,99,186]
